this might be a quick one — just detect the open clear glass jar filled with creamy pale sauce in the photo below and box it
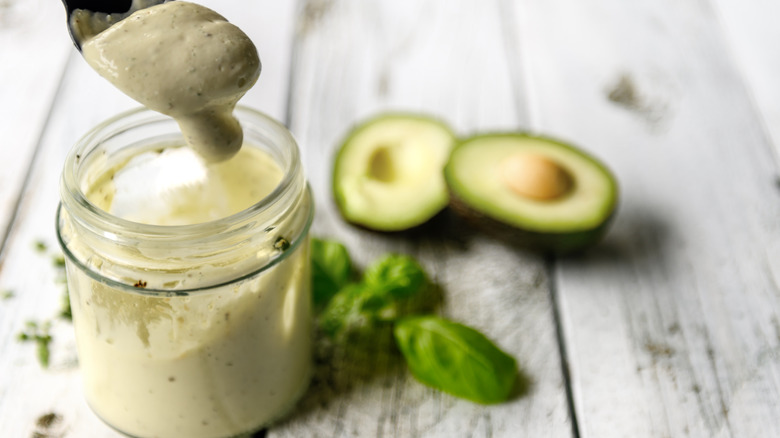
[57,107,313,438]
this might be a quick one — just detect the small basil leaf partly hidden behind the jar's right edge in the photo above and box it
[311,238,352,308]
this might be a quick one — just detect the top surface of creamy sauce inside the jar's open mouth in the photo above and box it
[85,146,283,225]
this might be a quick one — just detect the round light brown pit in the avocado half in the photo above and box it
[500,152,573,201]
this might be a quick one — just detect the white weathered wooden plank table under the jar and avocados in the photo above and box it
[0,0,780,438]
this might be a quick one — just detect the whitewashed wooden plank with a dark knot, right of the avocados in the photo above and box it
[517,0,780,437]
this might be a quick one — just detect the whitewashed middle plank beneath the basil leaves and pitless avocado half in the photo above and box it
[269,1,571,437]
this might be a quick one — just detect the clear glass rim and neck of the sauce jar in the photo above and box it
[55,105,314,297]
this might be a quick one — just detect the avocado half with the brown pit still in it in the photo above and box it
[444,133,618,253]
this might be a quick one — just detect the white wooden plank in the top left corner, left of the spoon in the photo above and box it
[0,1,72,249]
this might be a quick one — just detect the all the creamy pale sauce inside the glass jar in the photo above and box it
[64,145,311,438]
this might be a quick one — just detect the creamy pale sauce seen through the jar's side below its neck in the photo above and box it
[68,240,311,438]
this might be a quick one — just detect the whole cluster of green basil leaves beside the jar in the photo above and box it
[312,239,518,404]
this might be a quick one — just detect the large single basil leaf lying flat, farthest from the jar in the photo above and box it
[394,316,518,404]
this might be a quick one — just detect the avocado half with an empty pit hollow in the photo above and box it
[333,114,455,231]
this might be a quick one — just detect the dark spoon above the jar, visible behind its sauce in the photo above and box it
[62,0,167,51]
